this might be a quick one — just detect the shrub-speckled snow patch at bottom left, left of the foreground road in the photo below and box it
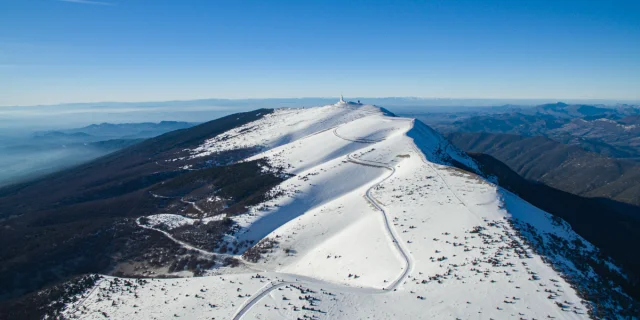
[66,274,278,319]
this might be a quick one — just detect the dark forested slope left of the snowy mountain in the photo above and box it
[0,109,272,301]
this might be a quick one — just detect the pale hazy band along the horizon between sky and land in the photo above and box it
[0,96,638,134]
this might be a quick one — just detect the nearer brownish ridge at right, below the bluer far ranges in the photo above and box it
[447,132,640,205]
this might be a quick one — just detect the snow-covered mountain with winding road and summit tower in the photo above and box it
[58,101,631,319]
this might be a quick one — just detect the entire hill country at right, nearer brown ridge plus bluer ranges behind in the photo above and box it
[413,102,640,205]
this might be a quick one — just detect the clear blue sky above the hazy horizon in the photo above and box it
[0,0,640,105]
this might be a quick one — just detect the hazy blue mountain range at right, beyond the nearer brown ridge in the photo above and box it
[415,103,640,161]
